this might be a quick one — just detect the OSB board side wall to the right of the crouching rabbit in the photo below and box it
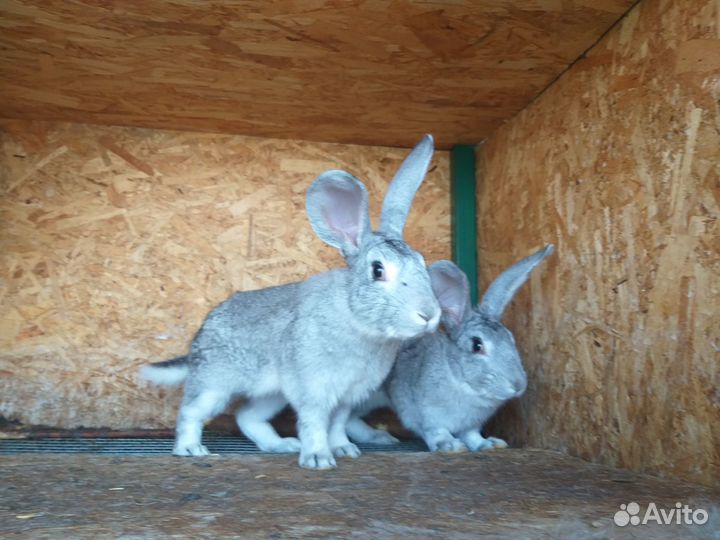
[478,0,720,483]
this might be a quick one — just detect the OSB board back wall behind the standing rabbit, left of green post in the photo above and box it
[0,121,450,428]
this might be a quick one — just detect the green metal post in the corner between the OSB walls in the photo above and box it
[450,144,478,306]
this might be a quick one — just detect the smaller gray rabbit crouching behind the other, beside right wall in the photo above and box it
[347,245,554,452]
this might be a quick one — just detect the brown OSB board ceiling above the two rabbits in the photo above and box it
[0,0,633,147]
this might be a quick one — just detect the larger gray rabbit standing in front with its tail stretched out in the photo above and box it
[141,135,441,469]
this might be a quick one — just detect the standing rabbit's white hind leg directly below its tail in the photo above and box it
[173,390,230,456]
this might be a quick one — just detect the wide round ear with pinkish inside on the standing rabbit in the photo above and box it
[306,170,371,257]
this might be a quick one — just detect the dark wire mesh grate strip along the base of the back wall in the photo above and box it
[0,434,427,456]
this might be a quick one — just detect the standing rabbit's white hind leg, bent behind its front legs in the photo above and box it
[235,394,300,453]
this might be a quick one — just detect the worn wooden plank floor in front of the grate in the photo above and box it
[0,449,720,539]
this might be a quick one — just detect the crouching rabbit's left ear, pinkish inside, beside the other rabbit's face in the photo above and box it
[428,261,470,335]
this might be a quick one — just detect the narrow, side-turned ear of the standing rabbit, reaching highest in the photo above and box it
[380,135,434,238]
